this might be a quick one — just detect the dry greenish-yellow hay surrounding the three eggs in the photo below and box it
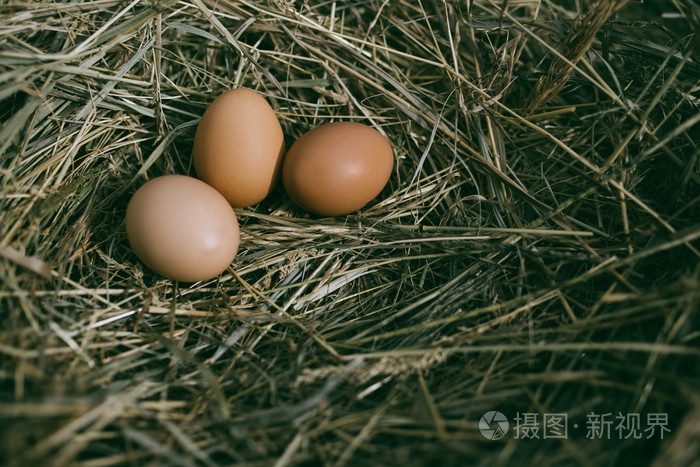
[0,0,700,467]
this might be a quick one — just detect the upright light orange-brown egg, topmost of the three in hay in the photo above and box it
[193,88,285,207]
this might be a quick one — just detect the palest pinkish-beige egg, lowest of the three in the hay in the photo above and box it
[126,175,239,282]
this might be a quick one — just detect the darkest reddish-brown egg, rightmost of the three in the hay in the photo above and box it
[282,122,394,216]
